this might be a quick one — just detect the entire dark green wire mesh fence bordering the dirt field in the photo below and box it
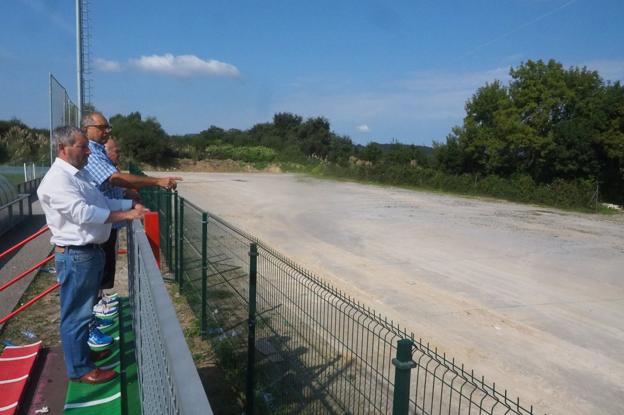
[130,164,534,414]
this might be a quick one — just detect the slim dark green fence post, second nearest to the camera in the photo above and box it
[245,242,258,415]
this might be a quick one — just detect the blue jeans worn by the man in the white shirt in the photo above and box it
[54,246,104,379]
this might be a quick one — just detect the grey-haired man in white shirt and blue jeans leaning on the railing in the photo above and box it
[37,127,144,383]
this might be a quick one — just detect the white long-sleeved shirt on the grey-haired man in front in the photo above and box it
[37,157,132,246]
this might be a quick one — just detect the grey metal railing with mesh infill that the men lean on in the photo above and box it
[128,220,212,415]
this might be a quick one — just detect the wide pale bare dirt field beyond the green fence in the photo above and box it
[154,172,624,414]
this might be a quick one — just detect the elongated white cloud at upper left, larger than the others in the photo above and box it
[131,53,240,77]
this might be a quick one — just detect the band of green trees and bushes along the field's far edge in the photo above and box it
[6,60,624,210]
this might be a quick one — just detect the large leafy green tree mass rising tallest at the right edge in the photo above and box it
[434,60,624,202]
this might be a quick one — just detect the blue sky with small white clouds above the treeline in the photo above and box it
[0,0,624,145]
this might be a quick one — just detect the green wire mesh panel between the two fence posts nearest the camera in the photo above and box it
[256,245,398,414]
